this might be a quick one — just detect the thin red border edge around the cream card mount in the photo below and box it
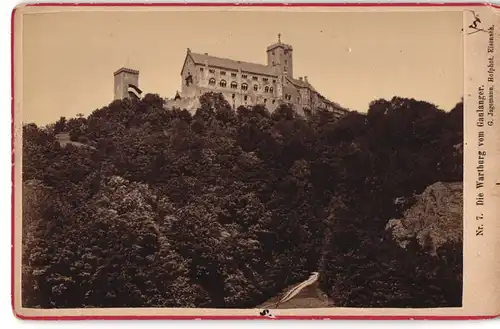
[11,2,500,321]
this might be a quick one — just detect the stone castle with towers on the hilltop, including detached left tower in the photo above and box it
[115,34,348,117]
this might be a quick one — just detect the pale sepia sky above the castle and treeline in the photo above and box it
[23,10,463,124]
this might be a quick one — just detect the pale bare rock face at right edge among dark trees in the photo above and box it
[386,182,463,255]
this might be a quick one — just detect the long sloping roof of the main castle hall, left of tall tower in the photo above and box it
[188,52,277,77]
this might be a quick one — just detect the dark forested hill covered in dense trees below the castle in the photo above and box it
[23,94,463,308]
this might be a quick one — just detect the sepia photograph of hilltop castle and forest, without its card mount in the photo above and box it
[16,6,464,315]
